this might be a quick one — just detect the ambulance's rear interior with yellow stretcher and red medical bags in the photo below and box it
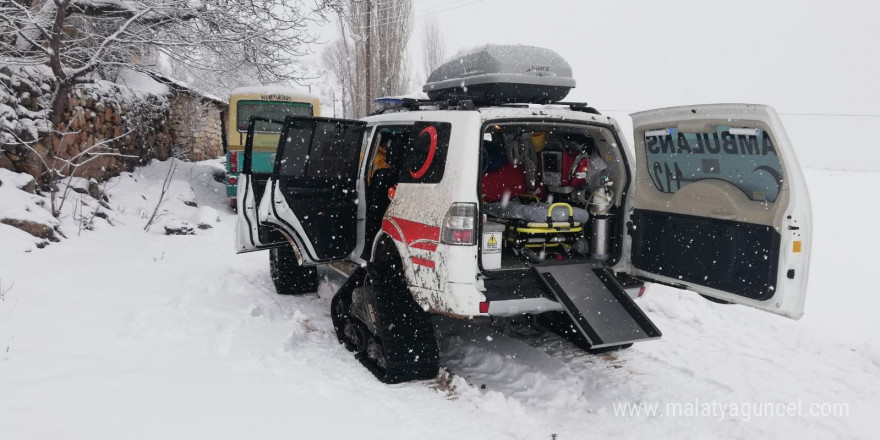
[480,122,628,271]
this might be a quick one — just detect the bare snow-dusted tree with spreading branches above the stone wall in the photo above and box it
[0,0,327,211]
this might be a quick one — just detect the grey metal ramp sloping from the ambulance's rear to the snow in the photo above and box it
[534,263,661,348]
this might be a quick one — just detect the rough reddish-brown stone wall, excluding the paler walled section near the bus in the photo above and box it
[0,67,171,180]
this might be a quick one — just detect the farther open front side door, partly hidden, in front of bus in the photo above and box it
[235,117,287,254]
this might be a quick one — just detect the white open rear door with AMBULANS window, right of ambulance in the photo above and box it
[627,104,812,319]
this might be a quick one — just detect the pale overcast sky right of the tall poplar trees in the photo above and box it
[312,0,880,170]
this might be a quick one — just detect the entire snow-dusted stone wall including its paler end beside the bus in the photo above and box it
[0,66,226,180]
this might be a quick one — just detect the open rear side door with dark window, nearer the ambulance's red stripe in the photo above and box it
[259,116,366,265]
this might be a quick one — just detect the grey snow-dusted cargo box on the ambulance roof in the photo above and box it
[423,45,575,105]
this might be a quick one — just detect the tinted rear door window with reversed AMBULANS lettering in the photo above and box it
[645,125,784,202]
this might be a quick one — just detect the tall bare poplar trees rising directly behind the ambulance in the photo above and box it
[323,0,413,117]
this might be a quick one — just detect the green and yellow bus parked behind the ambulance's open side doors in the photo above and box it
[226,86,321,208]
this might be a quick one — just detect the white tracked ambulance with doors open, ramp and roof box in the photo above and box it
[237,46,812,383]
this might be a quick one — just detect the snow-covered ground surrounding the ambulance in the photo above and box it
[0,162,880,439]
